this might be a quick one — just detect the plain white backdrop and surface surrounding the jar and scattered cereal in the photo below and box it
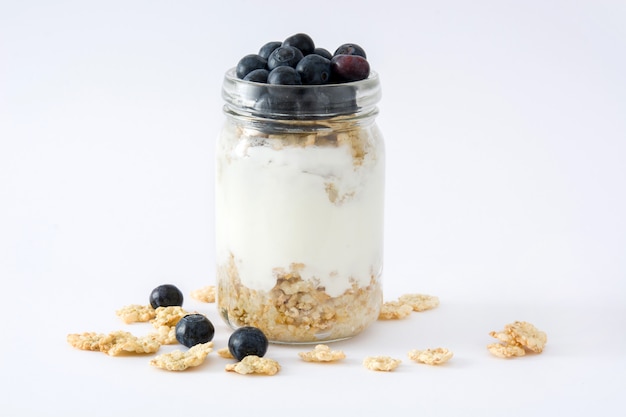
[0,0,626,416]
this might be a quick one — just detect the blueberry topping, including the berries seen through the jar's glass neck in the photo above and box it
[229,33,371,115]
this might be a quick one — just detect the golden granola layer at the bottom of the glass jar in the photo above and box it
[217,252,382,343]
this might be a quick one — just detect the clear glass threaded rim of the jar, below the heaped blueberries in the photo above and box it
[222,68,382,119]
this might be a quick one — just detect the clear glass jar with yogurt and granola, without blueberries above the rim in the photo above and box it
[215,70,385,343]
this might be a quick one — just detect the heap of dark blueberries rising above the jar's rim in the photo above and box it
[236,33,370,85]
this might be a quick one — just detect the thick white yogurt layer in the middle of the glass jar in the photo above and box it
[216,128,384,297]
